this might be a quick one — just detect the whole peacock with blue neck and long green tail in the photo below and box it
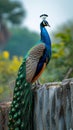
[8,14,51,130]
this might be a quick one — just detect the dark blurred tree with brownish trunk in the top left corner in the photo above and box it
[0,0,26,49]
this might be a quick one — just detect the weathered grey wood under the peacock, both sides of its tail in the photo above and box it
[0,78,73,130]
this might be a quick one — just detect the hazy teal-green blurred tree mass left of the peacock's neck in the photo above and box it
[4,28,39,57]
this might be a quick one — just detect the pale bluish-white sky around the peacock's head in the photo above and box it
[22,0,73,32]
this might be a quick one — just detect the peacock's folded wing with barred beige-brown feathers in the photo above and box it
[26,43,45,82]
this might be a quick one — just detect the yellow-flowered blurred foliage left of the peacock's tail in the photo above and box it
[0,51,22,101]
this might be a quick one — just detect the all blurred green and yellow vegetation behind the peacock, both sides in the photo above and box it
[0,0,73,102]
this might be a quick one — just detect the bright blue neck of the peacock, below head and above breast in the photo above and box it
[40,25,51,49]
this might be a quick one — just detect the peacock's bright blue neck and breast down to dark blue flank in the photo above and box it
[34,27,51,77]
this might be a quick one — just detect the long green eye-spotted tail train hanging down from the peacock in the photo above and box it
[8,59,33,130]
